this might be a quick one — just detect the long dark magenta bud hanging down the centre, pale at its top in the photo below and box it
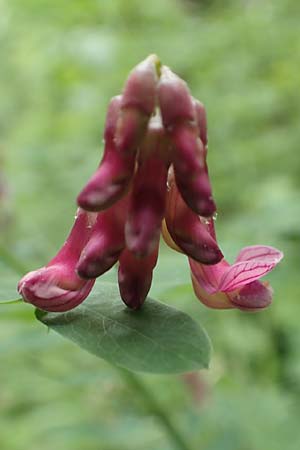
[125,119,170,257]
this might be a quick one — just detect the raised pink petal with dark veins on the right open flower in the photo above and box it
[219,257,278,292]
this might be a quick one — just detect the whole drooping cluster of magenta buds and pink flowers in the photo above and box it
[18,55,282,311]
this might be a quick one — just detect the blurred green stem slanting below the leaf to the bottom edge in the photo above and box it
[114,366,192,450]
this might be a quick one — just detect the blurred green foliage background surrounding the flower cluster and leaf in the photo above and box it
[0,0,300,450]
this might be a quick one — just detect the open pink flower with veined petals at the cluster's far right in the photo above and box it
[189,229,283,311]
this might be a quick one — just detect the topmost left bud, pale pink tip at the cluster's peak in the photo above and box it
[116,55,160,153]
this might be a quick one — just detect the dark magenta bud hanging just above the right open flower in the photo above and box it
[165,177,223,264]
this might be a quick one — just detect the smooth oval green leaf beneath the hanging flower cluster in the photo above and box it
[36,282,211,373]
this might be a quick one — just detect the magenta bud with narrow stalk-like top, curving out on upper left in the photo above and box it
[77,96,135,211]
